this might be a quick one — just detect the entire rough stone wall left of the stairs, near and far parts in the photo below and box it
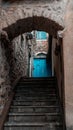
[0,31,28,114]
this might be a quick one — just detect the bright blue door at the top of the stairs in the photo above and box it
[32,58,51,77]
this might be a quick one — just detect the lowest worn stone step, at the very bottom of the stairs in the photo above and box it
[4,122,62,130]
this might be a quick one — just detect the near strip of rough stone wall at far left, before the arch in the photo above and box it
[0,32,11,114]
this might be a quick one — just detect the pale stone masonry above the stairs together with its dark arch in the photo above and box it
[0,0,66,39]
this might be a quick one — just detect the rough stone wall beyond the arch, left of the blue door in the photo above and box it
[11,34,28,83]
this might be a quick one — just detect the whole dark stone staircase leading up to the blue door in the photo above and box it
[4,77,63,130]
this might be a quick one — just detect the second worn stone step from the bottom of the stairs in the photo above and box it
[8,113,61,123]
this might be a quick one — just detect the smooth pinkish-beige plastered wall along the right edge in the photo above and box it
[63,0,73,130]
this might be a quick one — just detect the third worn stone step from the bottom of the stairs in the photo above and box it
[10,105,60,113]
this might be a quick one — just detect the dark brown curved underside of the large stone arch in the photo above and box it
[3,16,63,40]
